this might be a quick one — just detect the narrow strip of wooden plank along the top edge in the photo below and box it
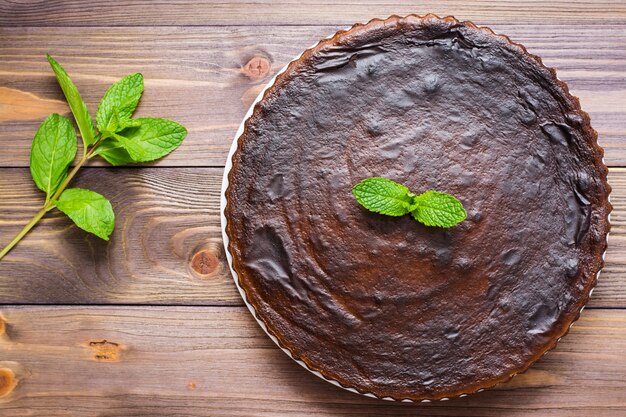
[0,0,626,26]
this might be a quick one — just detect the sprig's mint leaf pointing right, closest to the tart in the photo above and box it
[114,118,187,162]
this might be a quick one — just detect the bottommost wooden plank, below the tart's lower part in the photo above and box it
[0,307,626,417]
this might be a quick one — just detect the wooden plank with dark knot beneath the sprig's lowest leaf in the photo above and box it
[0,168,626,308]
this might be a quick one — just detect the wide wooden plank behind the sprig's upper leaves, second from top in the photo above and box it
[0,24,626,167]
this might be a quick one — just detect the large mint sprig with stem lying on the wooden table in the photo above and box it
[0,55,187,259]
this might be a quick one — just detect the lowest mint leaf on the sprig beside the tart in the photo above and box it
[56,188,115,240]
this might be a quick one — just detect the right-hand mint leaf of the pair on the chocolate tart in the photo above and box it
[411,191,467,227]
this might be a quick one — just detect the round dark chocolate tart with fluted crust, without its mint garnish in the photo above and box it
[222,15,611,401]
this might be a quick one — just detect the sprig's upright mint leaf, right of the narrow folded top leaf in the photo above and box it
[96,73,143,132]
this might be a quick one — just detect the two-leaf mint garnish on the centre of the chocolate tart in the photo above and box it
[352,177,467,228]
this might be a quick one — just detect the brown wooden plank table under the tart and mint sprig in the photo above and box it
[0,0,626,417]
